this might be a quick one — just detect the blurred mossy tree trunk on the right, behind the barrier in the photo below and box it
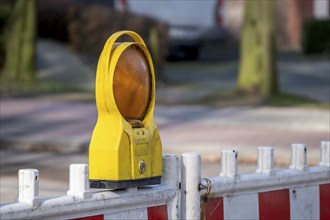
[238,0,278,97]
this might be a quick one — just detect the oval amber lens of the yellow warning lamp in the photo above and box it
[113,46,151,121]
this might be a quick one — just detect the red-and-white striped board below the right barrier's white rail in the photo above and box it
[205,177,330,220]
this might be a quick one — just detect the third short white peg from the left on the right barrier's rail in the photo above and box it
[290,144,308,171]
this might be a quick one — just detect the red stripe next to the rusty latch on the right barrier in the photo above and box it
[205,198,224,220]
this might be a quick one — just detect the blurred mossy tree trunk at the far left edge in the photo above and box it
[4,0,36,82]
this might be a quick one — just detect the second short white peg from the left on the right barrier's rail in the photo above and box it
[256,147,275,175]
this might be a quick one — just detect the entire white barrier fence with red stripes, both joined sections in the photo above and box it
[0,141,330,220]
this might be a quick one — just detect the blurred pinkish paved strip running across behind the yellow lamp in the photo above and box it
[0,97,330,164]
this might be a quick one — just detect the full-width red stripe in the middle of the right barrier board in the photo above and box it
[258,189,290,220]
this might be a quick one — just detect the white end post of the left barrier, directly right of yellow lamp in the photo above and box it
[162,154,180,219]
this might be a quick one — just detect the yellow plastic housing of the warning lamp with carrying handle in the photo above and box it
[89,31,162,186]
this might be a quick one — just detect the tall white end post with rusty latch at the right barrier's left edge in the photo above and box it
[180,152,201,219]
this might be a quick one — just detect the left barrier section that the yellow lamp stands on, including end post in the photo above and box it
[0,155,179,220]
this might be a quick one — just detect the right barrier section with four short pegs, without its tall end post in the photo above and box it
[195,142,330,220]
